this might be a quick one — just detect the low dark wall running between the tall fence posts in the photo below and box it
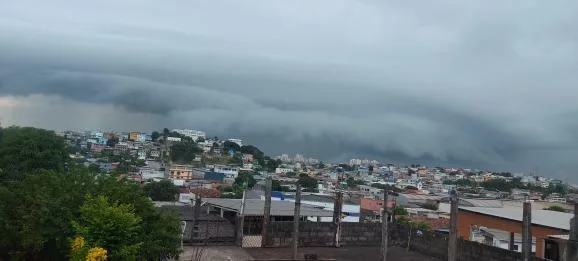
[258,222,545,261]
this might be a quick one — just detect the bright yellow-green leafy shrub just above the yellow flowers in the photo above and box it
[72,196,142,260]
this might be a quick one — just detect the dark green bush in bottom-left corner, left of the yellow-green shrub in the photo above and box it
[0,170,94,260]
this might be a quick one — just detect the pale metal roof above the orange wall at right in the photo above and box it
[459,207,573,231]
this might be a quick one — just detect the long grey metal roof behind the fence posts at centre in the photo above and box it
[203,198,333,217]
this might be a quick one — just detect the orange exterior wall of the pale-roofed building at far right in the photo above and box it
[458,209,568,257]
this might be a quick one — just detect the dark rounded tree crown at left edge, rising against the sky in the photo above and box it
[0,127,69,176]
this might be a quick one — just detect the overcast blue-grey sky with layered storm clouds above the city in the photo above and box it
[0,0,578,181]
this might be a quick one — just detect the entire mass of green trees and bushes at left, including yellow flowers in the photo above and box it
[0,127,181,260]
